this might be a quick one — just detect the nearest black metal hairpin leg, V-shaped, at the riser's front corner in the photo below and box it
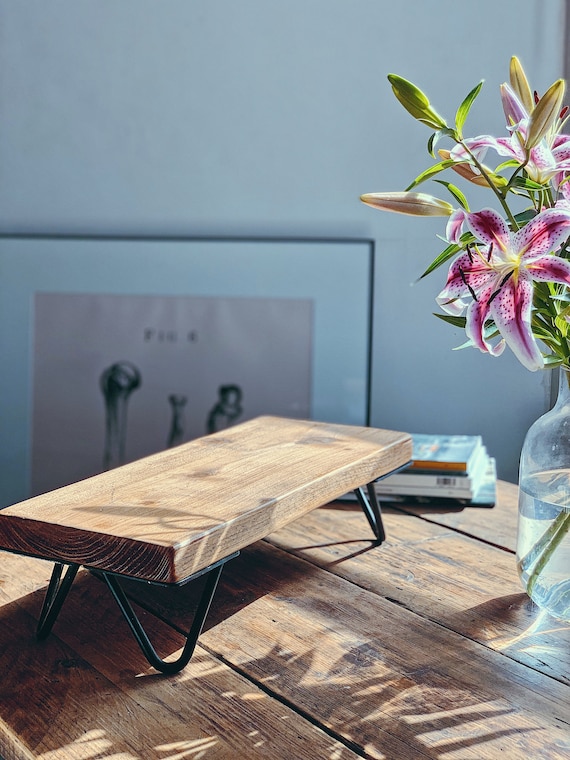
[101,552,235,675]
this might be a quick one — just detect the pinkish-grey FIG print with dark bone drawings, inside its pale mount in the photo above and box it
[31,293,314,493]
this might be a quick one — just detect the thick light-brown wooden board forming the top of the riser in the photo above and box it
[0,417,412,583]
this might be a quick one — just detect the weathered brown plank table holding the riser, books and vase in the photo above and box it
[0,483,570,760]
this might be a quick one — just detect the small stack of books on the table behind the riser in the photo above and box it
[375,434,497,507]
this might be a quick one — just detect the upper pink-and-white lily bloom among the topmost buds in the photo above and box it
[450,83,570,188]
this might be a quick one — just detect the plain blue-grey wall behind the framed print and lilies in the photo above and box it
[0,0,564,479]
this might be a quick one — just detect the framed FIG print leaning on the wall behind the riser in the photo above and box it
[0,236,374,507]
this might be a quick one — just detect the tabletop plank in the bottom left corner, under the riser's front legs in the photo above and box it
[0,555,357,760]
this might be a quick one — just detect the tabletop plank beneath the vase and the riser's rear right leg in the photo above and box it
[267,505,570,683]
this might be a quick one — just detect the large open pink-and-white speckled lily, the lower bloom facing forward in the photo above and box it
[437,208,570,371]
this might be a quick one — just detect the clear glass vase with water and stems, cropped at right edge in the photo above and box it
[517,368,570,620]
